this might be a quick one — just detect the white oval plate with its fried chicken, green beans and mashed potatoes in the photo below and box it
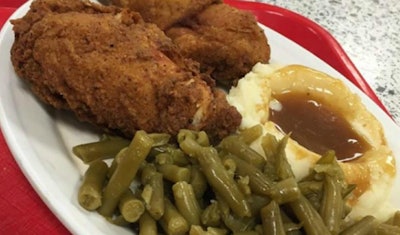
[0,0,400,234]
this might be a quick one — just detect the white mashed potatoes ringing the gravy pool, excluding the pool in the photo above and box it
[227,64,395,220]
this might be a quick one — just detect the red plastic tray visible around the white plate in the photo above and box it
[0,0,387,234]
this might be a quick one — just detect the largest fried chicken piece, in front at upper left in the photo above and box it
[11,0,241,137]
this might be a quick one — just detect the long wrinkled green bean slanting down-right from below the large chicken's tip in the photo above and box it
[179,133,251,217]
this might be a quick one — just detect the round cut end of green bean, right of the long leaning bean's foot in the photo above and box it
[119,189,145,223]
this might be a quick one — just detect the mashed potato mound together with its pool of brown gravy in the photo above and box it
[227,64,396,220]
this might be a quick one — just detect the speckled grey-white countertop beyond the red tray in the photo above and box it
[253,0,400,125]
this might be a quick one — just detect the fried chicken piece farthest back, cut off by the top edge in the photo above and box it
[110,0,220,30]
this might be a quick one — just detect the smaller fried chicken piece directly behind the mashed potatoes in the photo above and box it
[166,4,270,84]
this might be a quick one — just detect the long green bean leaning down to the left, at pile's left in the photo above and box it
[99,131,153,217]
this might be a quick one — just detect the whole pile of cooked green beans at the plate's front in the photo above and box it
[73,126,400,235]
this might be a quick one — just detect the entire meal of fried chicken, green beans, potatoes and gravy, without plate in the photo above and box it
[7,0,400,234]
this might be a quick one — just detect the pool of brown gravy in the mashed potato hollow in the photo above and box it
[270,92,370,161]
